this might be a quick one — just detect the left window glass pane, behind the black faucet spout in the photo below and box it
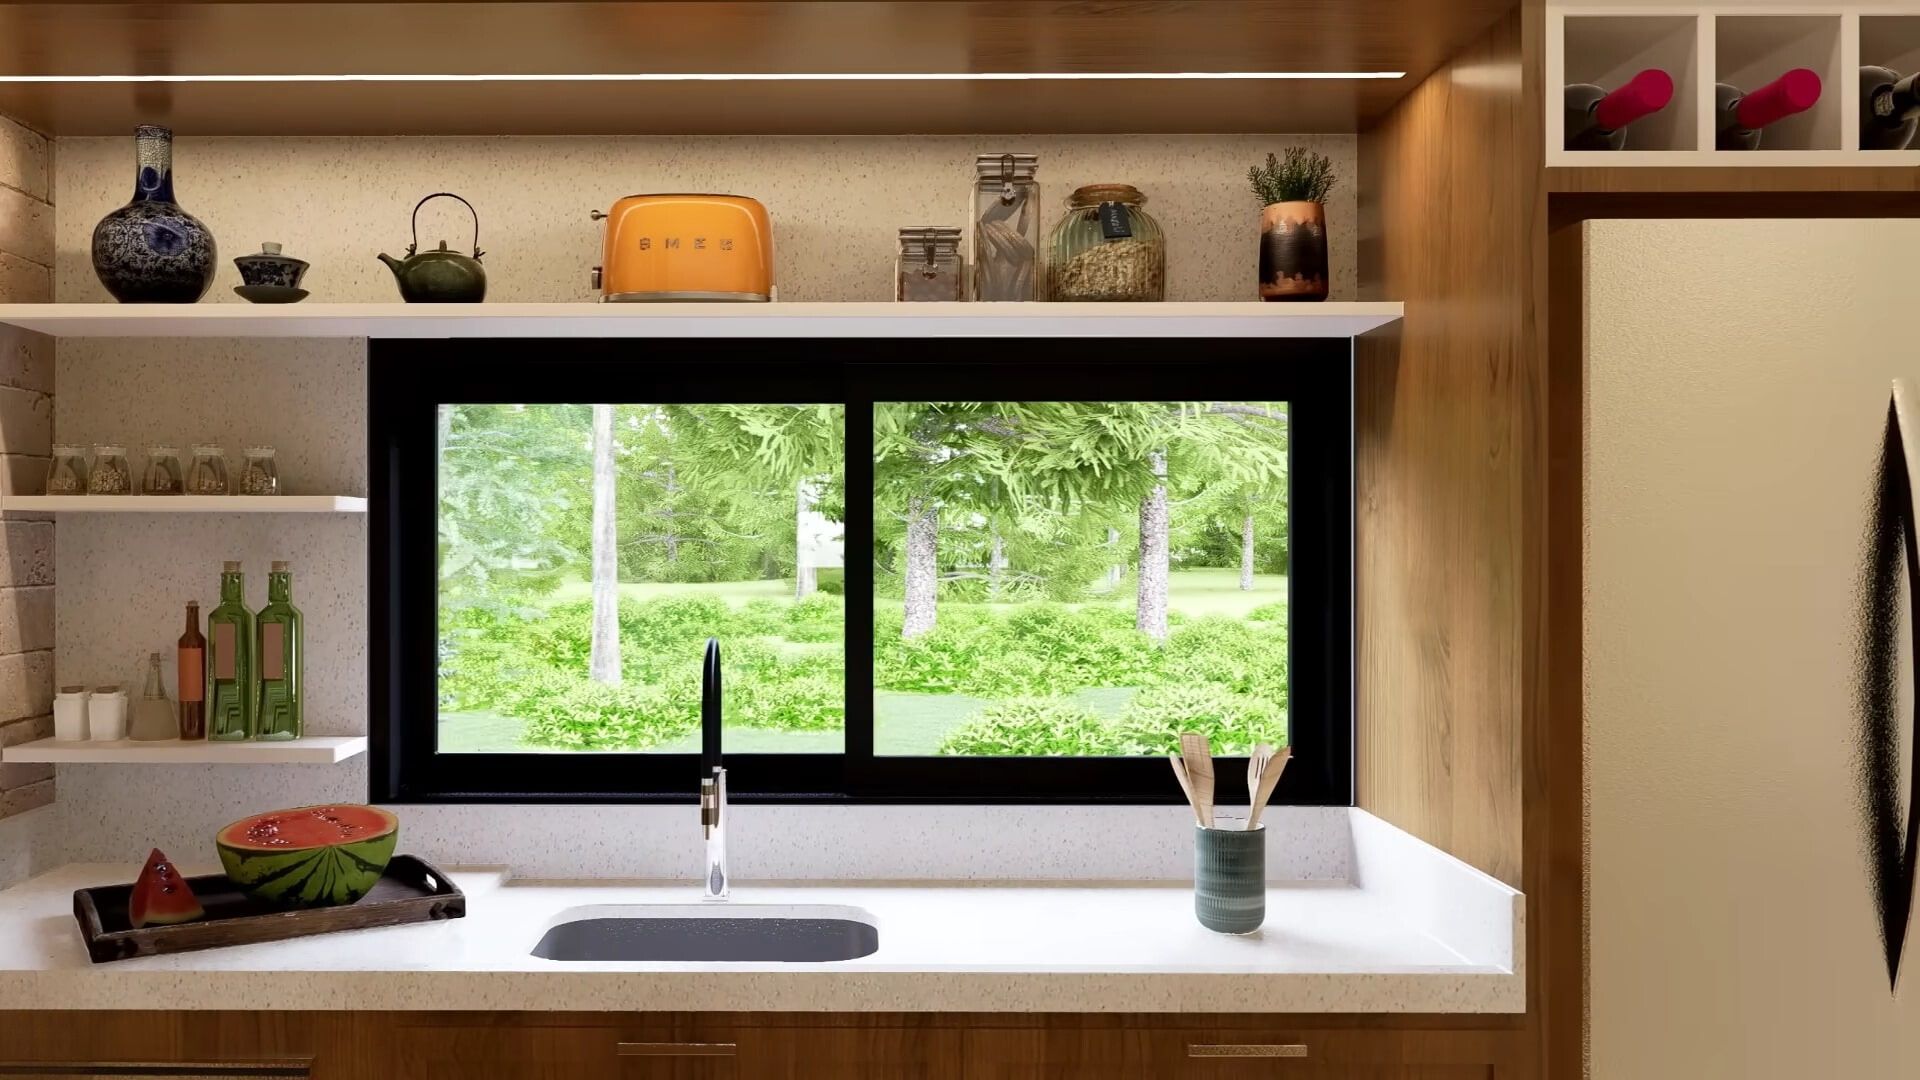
[438,404,845,753]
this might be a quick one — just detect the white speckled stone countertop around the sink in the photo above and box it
[0,811,1524,1013]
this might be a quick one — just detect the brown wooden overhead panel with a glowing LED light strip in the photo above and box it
[0,0,1513,135]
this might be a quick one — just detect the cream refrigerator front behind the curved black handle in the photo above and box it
[1586,219,1920,1080]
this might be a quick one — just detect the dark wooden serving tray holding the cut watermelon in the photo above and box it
[73,855,467,963]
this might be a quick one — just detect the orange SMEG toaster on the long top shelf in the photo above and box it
[593,194,774,302]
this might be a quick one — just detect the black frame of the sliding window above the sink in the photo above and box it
[367,338,1354,805]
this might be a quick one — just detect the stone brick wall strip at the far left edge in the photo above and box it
[0,117,54,819]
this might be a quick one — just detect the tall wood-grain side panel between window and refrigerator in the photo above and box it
[1356,12,1544,886]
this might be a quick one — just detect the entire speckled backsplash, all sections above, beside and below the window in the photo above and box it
[26,135,1356,882]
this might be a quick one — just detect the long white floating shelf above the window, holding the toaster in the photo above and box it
[0,302,1402,338]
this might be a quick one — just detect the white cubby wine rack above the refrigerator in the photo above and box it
[1544,0,1920,167]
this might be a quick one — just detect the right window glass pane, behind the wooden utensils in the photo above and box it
[874,402,1288,757]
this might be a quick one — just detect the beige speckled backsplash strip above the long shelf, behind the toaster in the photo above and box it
[54,133,1357,304]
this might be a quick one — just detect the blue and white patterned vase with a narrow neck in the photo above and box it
[94,125,217,304]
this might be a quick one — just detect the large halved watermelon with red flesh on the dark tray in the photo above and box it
[215,803,399,907]
